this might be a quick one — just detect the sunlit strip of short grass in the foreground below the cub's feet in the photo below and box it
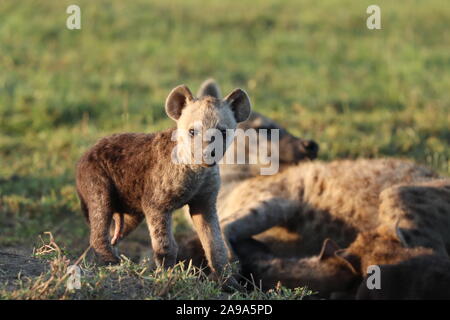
[0,233,313,300]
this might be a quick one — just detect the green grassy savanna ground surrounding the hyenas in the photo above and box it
[0,0,450,299]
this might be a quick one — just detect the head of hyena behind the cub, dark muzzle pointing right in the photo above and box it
[197,79,319,170]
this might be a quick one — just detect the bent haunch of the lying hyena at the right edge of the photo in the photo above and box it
[380,179,450,255]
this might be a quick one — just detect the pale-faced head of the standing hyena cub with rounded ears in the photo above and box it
[166,85,251,166]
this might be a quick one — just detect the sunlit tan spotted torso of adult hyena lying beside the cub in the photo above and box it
[180,159,450,270]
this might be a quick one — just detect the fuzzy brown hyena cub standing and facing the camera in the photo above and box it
[76,85,251,282]
